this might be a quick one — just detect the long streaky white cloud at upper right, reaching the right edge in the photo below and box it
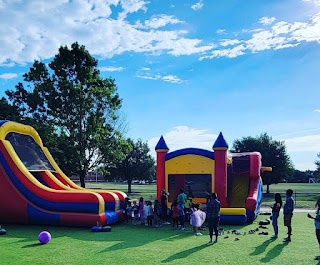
[199,12,320,60]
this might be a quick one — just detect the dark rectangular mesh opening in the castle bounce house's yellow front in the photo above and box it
[168,174,212,202]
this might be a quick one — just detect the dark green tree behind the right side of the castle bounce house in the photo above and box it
[233,133,294,193]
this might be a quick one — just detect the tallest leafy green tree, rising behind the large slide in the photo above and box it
[6,43,126,187]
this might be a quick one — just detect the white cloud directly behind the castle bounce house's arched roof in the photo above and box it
[148,125,218,156]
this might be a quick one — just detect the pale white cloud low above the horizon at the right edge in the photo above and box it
[285,134,320,152]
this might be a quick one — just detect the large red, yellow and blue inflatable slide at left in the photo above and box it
[0,120,127,227]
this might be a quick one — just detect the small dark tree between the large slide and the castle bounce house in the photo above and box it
[110,138,156,193]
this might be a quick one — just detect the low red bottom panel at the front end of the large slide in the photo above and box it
[60,213,107,227]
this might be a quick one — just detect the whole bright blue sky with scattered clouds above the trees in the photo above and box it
[0,0,320,170]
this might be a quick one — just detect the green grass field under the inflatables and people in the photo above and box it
[0,183,320,265]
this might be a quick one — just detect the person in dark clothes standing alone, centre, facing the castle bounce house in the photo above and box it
[207,193,221,244]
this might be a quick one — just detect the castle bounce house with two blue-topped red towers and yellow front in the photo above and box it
[155,133,271,225]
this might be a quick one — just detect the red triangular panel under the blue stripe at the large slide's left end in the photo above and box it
[0,164,28,223]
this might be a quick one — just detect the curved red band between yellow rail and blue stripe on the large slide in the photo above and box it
[0,142,99,203]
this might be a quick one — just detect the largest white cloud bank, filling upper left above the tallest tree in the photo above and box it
[0,0,213,64]
